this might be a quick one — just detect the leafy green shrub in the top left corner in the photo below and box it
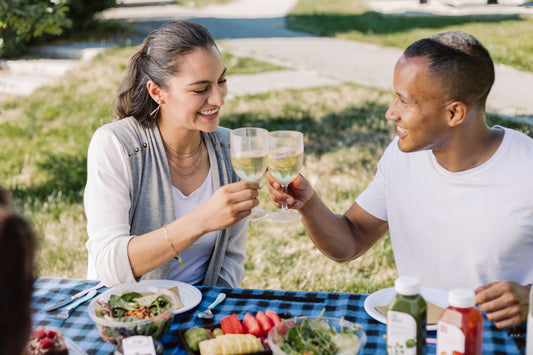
[0,0,72,58]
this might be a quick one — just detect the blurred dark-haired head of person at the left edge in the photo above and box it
[0,187,35,355]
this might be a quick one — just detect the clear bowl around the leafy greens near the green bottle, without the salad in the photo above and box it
[267,316,366,355]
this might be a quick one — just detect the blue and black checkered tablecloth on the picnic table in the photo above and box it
[32,277,520,355]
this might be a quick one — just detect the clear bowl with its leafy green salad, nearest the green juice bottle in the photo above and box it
[267,315,366,355]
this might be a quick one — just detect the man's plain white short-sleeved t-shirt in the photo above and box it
[356,127,533,290]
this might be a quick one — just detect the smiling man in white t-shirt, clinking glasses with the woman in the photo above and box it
[268,32,533,328]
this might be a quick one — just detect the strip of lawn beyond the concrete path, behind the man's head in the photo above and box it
[287,0,533,71]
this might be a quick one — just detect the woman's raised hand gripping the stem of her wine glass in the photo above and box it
[198,181,261,233]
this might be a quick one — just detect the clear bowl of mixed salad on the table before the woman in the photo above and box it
[87,283,179,345]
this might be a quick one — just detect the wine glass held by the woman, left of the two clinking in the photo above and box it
[230,127,268,221]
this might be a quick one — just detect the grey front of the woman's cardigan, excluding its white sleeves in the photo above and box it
[108,117,248,287]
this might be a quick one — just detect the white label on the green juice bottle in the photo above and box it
[387,311,417,355]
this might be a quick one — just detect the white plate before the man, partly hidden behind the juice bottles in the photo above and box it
[364,287,448,330]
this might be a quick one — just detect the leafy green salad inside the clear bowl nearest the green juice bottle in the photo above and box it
[282,311,360,355]
